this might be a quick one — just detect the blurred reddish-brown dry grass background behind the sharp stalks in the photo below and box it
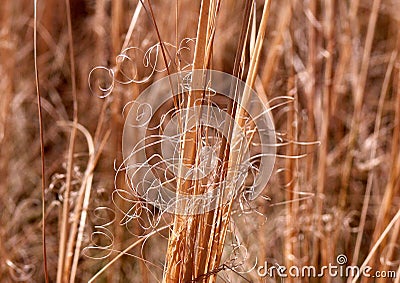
[0,0,400,282]
